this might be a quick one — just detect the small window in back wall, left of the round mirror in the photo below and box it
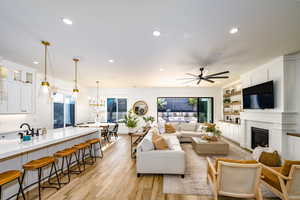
[107,98,127,123]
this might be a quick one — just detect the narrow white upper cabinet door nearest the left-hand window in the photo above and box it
[21,84,32,113]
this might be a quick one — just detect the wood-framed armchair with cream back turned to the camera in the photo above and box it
[207,158,263,200]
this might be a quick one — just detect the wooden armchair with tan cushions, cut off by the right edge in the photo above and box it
[261,160,300,200]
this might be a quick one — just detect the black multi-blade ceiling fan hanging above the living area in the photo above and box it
[178,67,229,85]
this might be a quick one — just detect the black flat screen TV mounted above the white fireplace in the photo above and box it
[243,81,274,109]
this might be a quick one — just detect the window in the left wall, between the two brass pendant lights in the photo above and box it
[53,93,75,128]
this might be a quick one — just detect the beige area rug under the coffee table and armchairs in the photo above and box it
[163,142,277,199]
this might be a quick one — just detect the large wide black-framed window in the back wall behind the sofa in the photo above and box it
[157,97,214,123]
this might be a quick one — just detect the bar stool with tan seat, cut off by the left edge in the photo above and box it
[0,170,25,200]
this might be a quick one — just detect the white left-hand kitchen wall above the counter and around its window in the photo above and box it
[0,61,89,133]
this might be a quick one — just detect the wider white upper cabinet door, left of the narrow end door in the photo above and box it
[7,81,21,113]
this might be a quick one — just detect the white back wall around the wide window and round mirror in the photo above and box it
[89,87,222,132]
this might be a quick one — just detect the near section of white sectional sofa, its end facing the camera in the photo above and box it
[136,128,186,177]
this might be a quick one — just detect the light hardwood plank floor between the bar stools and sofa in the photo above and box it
[22,136,272,200]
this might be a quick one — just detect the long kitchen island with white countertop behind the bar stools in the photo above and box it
[0,128,100,199]
